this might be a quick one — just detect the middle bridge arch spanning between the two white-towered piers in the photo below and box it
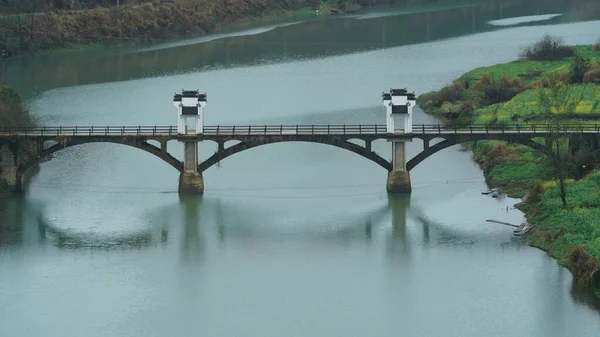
[198,138,392,172]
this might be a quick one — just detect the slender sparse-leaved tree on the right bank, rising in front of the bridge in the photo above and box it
[539,83,577,207]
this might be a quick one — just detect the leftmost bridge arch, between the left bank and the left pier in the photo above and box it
[18,138,183,175]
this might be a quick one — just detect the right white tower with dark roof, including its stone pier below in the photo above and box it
[382,89,416,193]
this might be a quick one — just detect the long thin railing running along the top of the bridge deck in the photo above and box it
[0,123,600,136]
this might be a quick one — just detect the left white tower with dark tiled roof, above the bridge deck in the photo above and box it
[173,90,206,135]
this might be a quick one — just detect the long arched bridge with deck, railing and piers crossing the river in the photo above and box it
[0,124,600,193]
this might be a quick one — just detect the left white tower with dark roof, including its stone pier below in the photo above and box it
[173,90,207,194]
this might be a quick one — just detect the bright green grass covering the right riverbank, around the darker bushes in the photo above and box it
[417,42,600,297]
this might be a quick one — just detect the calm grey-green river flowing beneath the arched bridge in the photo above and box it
[0,0,600,337]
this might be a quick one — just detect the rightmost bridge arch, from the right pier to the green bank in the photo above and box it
[406,135,553,171]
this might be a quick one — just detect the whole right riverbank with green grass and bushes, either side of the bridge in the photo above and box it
[418,37,600,297]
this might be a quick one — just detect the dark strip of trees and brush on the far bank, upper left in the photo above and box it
[0,0,492,58]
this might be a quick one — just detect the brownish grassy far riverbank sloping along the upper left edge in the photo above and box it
[0,0,390,59]
